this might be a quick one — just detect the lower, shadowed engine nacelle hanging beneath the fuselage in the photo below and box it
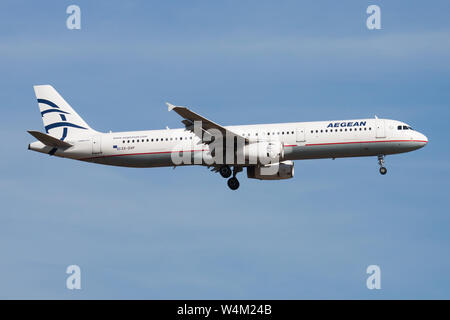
[247,161,294,180]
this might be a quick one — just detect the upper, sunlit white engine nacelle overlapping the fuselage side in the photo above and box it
[244,141,284,164]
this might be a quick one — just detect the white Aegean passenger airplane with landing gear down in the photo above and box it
[28,85,428,190]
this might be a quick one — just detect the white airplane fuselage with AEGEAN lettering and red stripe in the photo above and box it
[29,119,428,168]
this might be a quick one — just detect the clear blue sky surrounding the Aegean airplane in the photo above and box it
[0,1,450,299]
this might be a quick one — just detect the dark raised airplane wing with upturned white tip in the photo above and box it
[166,102,248,143]
